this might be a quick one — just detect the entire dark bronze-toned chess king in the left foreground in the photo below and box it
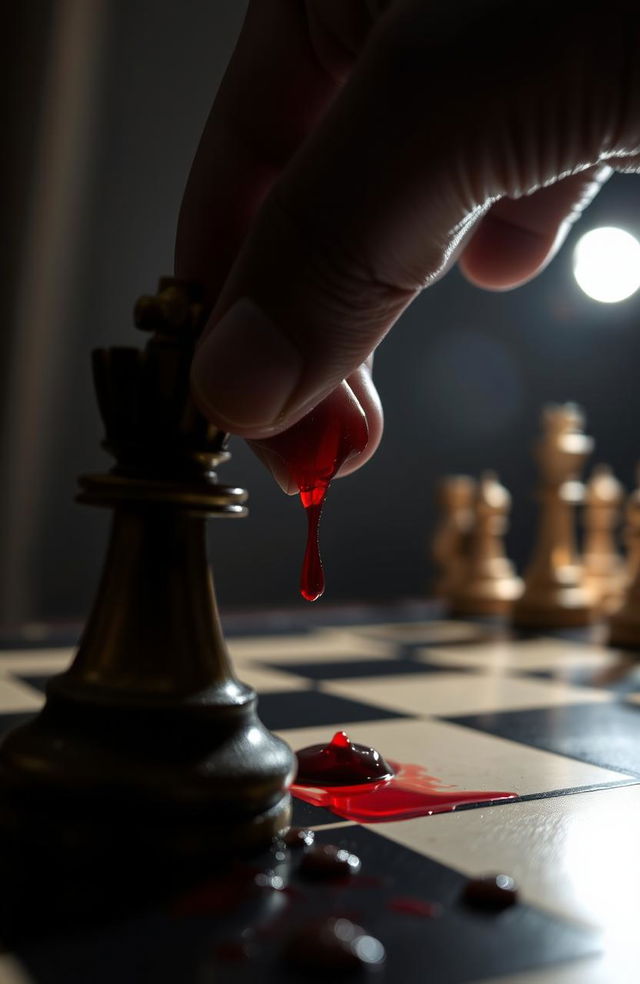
[0,278,293,870]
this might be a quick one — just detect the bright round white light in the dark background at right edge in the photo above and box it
[573,226,640,304]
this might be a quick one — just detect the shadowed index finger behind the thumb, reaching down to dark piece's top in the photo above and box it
[175,0,337,305]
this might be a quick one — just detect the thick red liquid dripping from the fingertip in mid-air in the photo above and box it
[255,383,369,601]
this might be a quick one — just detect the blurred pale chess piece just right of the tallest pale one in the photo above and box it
[582,465,625,614]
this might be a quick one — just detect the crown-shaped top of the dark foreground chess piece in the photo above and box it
[80,277,246,504]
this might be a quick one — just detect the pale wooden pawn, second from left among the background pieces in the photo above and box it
[452,471,523,615]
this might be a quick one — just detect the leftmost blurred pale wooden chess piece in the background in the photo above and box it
[432,475,476,601]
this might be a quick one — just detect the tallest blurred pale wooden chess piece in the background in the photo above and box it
[513,403,595,628]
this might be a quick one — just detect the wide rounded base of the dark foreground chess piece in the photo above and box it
[0,673,293,866]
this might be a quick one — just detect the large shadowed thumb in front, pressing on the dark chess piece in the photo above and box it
[193,0,640,438]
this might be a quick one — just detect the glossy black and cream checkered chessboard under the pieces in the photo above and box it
[0,609,640,984]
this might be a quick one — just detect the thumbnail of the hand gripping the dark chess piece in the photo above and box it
[191,297,302,431]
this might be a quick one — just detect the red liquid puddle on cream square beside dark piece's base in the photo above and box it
[291,732,518,823]
